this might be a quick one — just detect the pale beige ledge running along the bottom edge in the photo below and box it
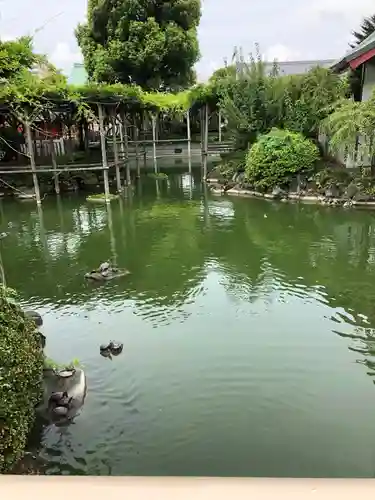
[0,476,374,500]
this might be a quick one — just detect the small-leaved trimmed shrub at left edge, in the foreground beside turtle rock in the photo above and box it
[0,287,43,473]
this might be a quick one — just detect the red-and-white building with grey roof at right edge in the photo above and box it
[331,33,375,101]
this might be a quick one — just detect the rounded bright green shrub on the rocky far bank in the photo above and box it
[246,129,319,190]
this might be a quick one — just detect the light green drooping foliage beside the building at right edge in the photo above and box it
[322,92,375,160]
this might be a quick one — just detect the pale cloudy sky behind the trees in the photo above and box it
[0,0,375,81]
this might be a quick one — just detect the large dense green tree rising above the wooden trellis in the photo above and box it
[76,0,201,90]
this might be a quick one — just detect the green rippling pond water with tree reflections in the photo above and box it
[0,171,375,477]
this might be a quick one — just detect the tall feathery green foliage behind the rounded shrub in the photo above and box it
[220,53,348,149]
